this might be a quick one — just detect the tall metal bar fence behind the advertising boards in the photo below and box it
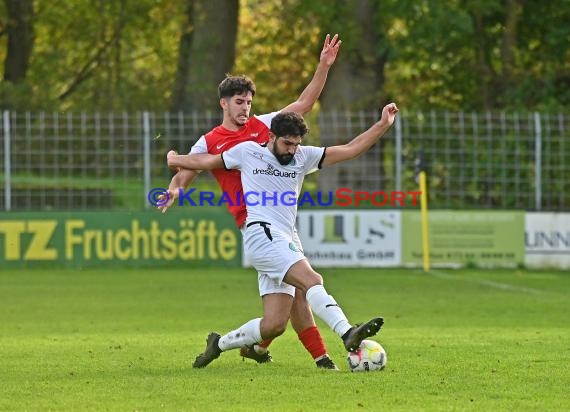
[0,110,570,211]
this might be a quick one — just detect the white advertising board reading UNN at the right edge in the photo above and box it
[525,212,570,268]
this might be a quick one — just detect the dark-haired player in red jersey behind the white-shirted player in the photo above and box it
[159,34,342,369]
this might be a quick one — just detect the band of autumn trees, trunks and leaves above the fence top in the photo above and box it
[0,0,570,113]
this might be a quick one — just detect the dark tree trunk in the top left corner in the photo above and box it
[4,0,34,83]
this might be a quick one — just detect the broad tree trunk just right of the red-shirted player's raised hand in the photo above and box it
[319,0,388,191]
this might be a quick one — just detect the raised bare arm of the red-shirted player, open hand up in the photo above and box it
[281,34,342,115]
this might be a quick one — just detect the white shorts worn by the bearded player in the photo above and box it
[242,223,305,296]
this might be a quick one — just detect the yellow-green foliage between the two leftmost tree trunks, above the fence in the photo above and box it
[2,0,181,110]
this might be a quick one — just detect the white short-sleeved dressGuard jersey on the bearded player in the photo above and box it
[222,142,325,235]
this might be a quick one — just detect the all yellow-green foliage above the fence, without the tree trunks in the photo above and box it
[0,0,570,112]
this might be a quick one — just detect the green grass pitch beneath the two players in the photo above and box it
[0,268,570,411]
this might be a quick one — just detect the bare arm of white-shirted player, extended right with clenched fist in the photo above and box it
[323,103,398,166]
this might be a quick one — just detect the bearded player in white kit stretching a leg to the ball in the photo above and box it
[167,103,398,368]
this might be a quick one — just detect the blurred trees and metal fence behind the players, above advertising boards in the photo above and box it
[0,0,570,268]
